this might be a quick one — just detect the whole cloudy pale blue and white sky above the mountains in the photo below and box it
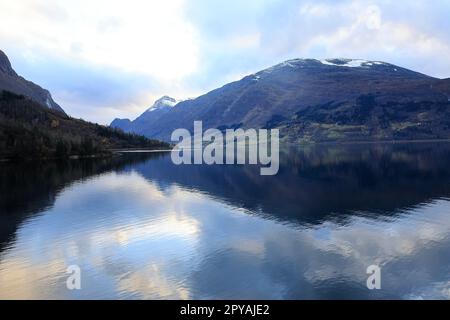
[0,0,450,124]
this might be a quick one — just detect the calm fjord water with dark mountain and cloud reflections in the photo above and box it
[0,143,450,299]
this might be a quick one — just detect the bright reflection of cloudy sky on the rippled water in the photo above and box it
[0,164,450,299]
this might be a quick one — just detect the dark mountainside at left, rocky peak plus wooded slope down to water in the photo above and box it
[0,53,169,159]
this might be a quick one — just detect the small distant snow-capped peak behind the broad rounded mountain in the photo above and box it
[110,96,180,134]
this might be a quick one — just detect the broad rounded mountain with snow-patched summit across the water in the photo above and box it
[110,59,450,142]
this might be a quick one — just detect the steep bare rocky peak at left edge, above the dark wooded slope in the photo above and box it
[0,50,64,113]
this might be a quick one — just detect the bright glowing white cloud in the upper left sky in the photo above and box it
[0,0,198,81]
